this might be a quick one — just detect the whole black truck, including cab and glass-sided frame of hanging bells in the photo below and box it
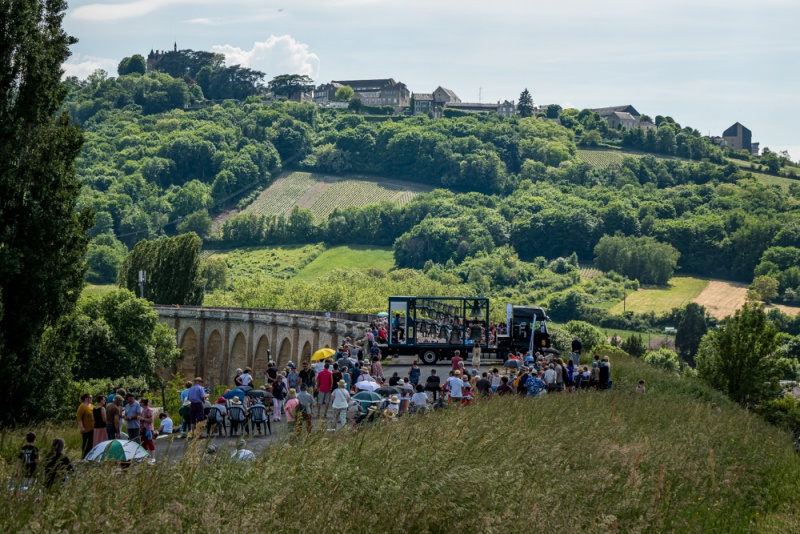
[380,297,550,365]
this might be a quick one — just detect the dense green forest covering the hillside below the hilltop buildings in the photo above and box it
[66,51,800,316]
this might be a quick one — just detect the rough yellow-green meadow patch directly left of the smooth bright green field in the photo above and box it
[209,245,325,279]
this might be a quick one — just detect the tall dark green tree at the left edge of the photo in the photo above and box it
[0,0,93,421]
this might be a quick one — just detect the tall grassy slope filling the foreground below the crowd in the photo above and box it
[0,356,800,532]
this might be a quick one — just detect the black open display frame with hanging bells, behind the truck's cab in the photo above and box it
[383,297,489,365]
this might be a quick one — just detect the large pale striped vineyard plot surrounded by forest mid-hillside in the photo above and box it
[234,172,431,219]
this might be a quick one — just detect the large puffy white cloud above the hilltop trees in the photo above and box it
[212,35,319,78]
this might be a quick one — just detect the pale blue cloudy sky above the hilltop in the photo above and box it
[64,0,800,160]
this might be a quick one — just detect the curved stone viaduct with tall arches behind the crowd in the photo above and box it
[155,306,370,384]
